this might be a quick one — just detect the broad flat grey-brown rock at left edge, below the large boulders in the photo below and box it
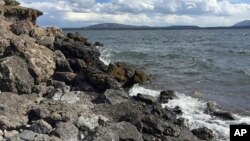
[0,92,37,129]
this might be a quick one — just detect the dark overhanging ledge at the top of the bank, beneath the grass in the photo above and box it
[4,6,43,24]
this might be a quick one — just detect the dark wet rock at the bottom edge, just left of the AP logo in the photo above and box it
[192,127,214,141]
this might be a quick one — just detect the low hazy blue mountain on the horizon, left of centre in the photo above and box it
[83,23,150,29]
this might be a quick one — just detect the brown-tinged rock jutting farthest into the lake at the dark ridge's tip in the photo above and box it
[107,62,150,86]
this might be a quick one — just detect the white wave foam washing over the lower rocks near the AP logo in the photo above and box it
[129,84,250,141]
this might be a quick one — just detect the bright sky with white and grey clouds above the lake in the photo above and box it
[19,0,250,27]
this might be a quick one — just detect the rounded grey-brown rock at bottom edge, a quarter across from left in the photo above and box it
[53,122,80,141]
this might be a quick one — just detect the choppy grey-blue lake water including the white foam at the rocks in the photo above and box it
[65,29,250,140]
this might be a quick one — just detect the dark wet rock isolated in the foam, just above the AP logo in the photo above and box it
[205,102,235,120]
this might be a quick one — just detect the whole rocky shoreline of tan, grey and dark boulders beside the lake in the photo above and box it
[0,0,233,141]
